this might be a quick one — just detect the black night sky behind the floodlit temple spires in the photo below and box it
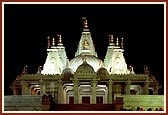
[4,4,164,95]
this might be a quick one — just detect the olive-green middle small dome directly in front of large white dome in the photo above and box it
[76,61,94,73]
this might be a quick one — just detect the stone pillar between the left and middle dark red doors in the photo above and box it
[73,78,79,104]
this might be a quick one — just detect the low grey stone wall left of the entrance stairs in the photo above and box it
[4,95,42,111]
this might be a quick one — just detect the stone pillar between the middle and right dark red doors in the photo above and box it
[92,79,97,104]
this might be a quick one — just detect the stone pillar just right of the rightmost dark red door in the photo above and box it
[108,79,113,104]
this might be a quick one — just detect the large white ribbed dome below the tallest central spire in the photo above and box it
[70,55,102,72]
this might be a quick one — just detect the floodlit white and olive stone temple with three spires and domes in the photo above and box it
[11,18,160,104]
